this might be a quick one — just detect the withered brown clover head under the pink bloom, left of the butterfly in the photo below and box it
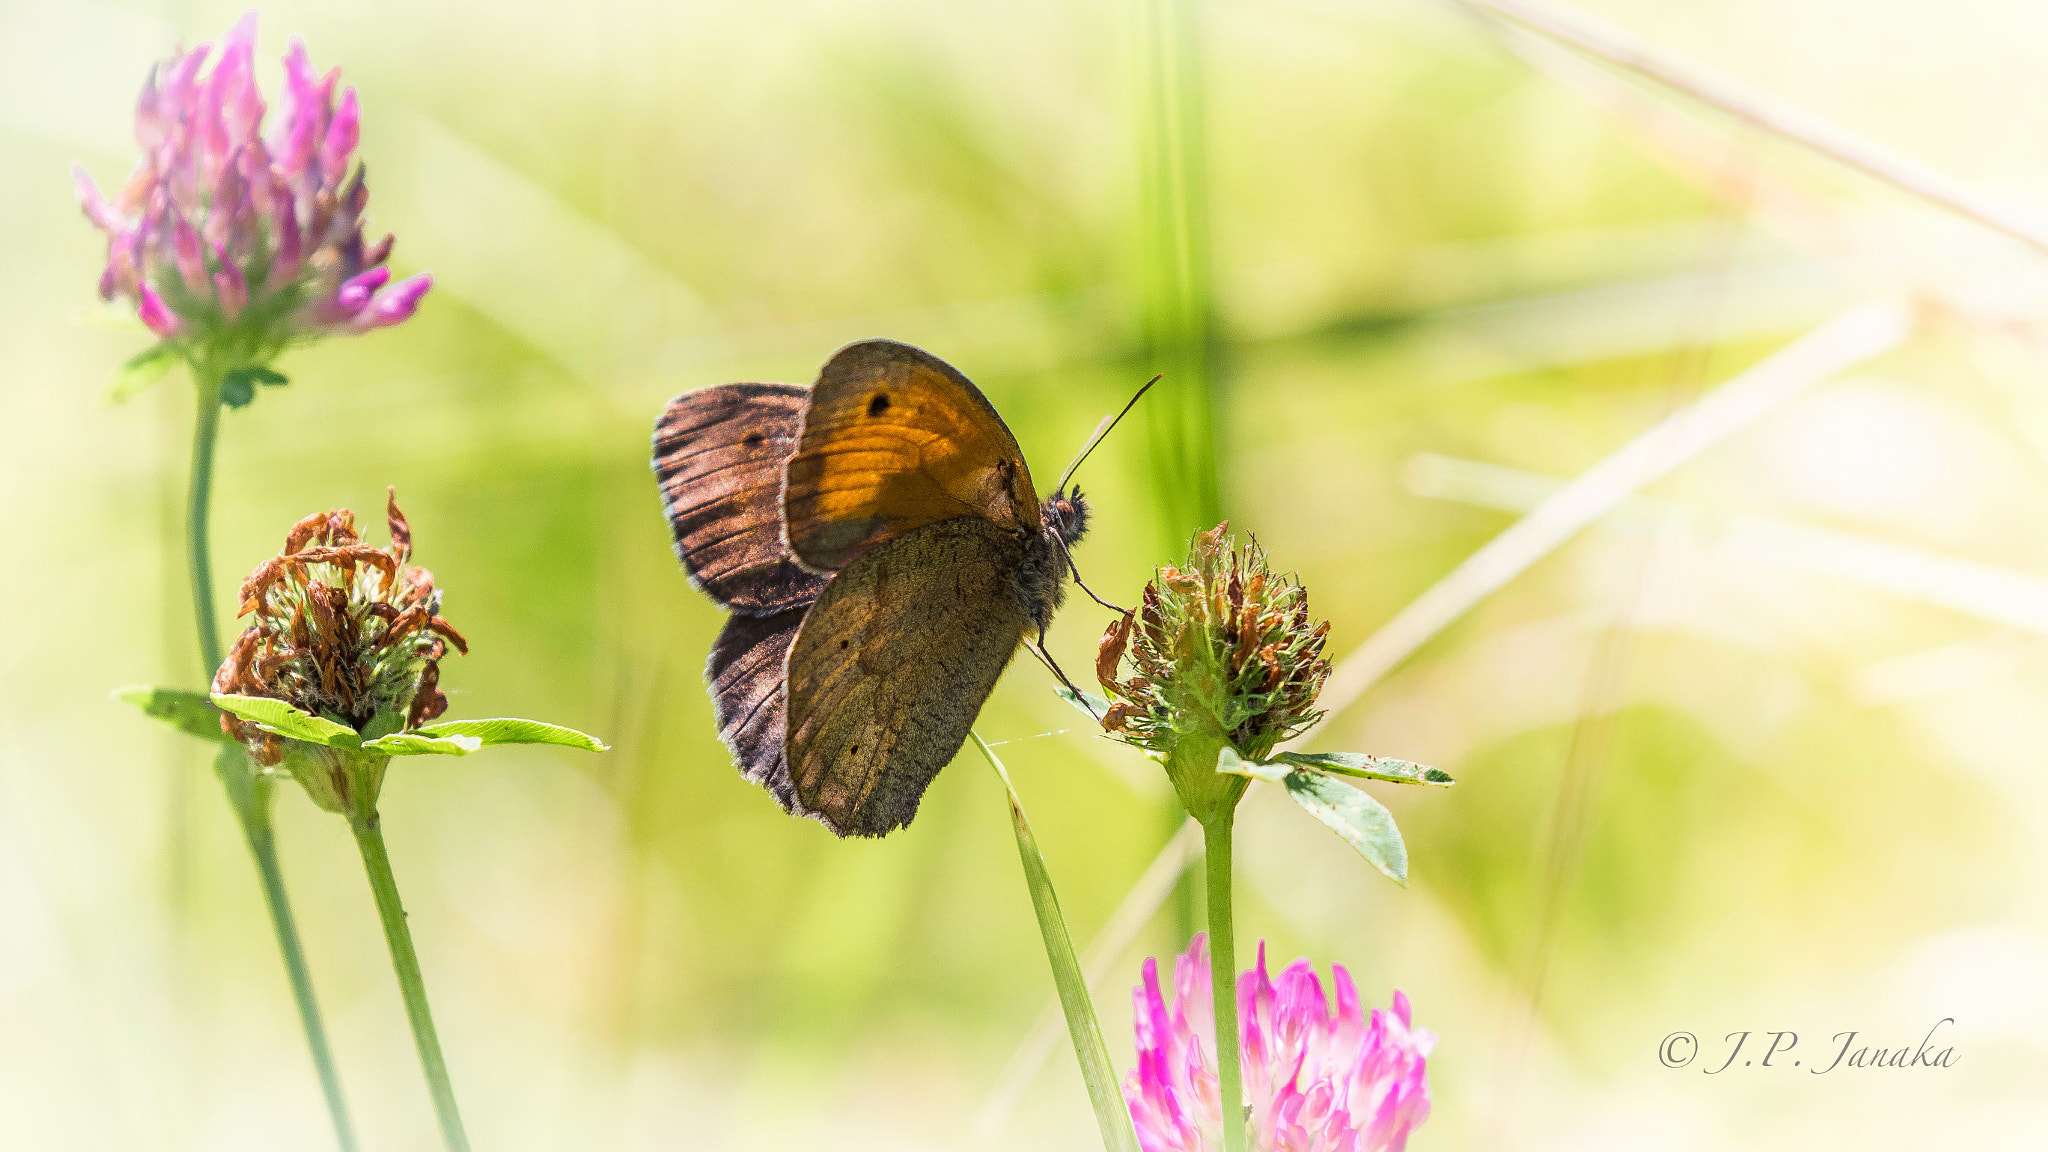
[213,483,469,765]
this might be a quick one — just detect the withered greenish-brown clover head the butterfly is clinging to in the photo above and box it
[1096,521,1329,760]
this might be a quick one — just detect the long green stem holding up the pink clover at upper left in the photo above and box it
[184,361,356,1152]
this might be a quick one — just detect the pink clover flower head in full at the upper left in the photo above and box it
[72,10,432,389]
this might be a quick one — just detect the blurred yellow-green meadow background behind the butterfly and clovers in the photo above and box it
[0,0,2048,1152]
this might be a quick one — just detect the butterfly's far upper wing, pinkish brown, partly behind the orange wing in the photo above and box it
[653,383,825,615]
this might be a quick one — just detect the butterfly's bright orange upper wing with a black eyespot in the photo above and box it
[782,340,1038,572]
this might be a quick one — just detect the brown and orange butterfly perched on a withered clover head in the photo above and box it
[653,340,1087,836]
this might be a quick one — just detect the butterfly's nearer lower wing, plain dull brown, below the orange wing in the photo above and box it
[784,517,1026,836]
